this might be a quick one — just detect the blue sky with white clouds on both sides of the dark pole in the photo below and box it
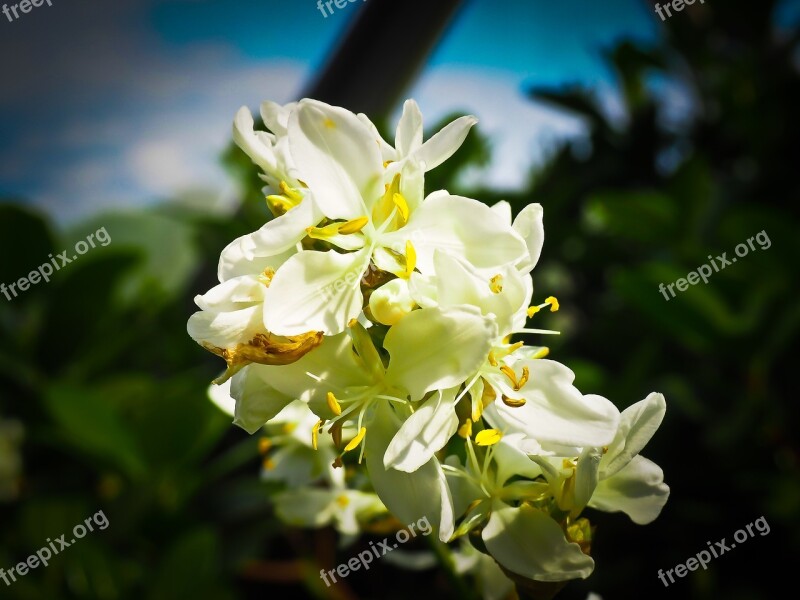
[0,0,760,221]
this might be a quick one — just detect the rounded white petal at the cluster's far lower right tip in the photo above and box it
[589,456,669,525]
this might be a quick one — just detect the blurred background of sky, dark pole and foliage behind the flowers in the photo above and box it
[0,0,800,600]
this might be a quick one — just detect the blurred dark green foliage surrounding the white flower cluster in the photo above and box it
[0,0,800,600]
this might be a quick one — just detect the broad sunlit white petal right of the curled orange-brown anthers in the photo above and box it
[484,359,619,447]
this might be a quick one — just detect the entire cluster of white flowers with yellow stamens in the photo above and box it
[188,99,669,581]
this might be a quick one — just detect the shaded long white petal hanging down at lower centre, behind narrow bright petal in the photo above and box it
[365,402,454,541]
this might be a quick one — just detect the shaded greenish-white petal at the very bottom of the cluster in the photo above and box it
[482,503,594,581]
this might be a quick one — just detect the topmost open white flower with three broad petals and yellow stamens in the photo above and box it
[265,100,527,335]
